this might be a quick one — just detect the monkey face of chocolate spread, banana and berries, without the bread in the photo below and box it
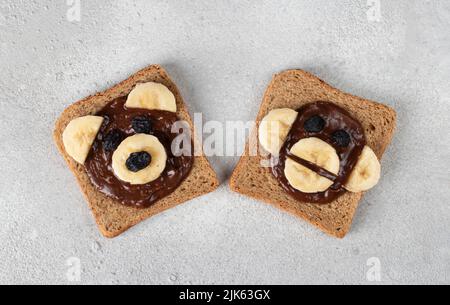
[259,102,380,204]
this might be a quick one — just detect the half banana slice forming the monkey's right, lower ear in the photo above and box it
[345,146,381,193]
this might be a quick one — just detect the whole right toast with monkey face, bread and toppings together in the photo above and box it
[230,70,396,238]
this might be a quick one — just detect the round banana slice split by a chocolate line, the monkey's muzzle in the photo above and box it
[284,138,340,194]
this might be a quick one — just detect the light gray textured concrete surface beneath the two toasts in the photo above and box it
[0,0,450,284]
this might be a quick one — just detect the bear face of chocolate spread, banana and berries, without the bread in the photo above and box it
[63,82,194,208]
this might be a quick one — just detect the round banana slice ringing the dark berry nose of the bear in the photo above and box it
[112,134,167,185]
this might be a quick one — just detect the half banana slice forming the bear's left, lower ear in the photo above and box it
[63,116,104,164]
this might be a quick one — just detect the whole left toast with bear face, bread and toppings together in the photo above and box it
[54,65,219,238]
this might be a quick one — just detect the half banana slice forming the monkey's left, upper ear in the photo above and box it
[259,108,298,156]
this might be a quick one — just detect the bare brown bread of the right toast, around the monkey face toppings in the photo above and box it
[230,70,396,238]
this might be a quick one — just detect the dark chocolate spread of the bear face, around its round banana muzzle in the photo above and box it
[85,97,194,208]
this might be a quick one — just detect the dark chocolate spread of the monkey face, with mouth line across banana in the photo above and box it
[271,102,366,204]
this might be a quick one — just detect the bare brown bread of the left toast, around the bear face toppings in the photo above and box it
[54,65,219,238]
